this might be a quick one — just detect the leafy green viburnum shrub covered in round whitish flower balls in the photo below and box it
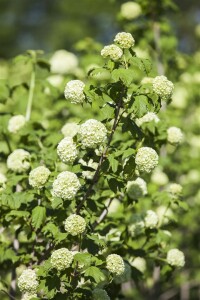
[0,32,185,300]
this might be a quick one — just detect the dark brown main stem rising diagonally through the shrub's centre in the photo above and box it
[76,99,122,214]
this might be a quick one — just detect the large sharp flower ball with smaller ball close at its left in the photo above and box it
[52,171,81,200]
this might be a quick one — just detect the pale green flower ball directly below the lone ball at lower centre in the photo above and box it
[51,248,74,271]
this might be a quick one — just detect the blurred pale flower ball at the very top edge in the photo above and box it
[120,1,142,20]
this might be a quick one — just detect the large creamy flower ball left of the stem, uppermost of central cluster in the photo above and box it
[79,119,107,148]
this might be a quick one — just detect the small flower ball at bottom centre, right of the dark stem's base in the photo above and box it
[106,254,125,275]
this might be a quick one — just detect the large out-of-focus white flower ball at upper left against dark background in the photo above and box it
[50,50,78,74]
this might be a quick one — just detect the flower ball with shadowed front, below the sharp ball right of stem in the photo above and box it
[126,177,147,200]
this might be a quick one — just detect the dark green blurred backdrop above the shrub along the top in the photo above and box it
[0,0,200,58]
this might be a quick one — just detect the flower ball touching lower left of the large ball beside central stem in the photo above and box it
[57,137,78,164]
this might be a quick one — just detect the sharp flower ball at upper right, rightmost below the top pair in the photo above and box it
[153,75,174,101]
